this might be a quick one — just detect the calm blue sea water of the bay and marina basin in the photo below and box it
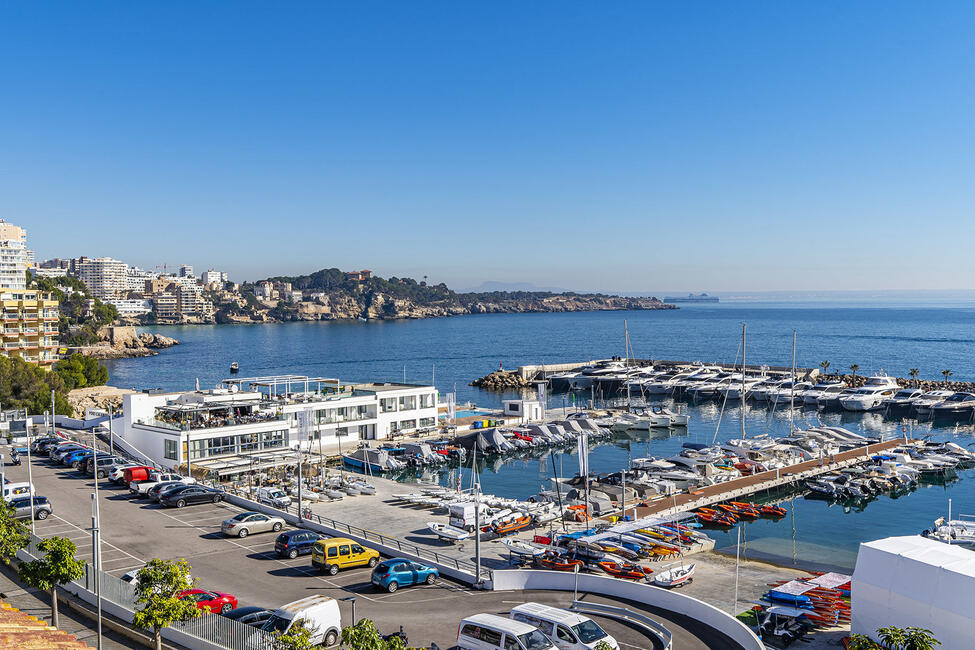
[106,302,975,568]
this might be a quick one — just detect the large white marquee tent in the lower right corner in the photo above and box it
[852,535,975,648]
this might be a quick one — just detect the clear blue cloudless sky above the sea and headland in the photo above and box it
[0,2,975,291]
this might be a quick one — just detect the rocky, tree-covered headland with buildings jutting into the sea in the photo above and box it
[201,268,677,324]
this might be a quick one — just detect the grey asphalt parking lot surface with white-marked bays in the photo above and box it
[4,436,731,648]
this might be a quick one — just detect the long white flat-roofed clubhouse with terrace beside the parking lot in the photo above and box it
[115,375,437,476]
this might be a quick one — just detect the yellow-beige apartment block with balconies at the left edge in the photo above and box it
[0,289,59,366]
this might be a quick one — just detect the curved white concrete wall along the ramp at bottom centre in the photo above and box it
[492,569,765,650]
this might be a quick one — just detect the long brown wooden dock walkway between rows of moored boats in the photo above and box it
[626,438,908,519]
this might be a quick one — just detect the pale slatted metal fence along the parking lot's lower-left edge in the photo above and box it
[23,535,275,650]
